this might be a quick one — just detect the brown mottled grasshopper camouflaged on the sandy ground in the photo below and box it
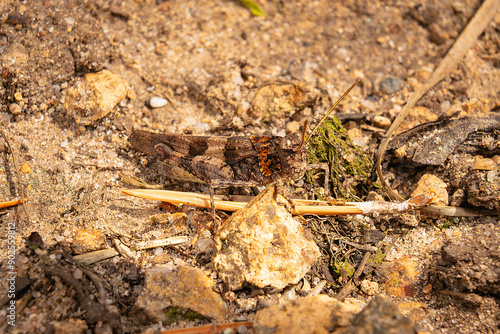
[129,80,359,222]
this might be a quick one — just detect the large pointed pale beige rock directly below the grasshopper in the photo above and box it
[214,186,320,290]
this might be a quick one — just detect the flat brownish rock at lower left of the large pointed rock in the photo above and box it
[135,263,228,322]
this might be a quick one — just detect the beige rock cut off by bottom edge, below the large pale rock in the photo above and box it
[254,295,361,334]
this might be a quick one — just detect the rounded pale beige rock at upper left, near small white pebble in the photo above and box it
[64,70,128,125]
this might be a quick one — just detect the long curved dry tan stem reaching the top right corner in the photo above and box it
[375,0,500,201]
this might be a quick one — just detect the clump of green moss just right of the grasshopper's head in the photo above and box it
[307,117,373,201]
